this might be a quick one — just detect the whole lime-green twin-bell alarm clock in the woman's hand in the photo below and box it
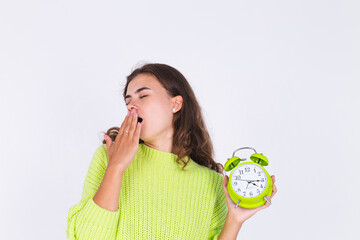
[224,147,273,208]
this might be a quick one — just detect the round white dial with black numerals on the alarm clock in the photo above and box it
[231,163,267,198]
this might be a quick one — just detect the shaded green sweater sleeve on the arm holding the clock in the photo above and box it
[208,174,228,240]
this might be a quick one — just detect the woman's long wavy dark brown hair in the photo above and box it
[103,63,224,176]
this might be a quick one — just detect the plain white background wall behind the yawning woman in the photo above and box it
[0,0,360,240]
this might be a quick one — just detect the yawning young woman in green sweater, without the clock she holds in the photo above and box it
[67,63,276,240]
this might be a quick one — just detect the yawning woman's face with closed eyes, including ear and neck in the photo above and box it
[125,74,178,143]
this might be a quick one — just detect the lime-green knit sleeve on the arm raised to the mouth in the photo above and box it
[66,144,120,240]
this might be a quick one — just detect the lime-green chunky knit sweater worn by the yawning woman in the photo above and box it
[66,143,228,240]
